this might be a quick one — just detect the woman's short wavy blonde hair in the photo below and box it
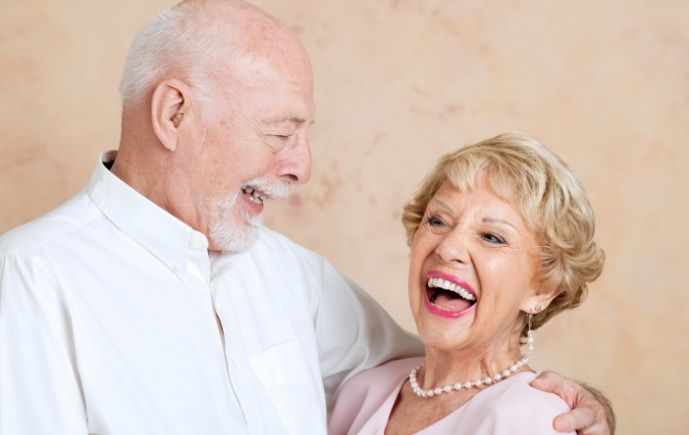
[402,133,605,336]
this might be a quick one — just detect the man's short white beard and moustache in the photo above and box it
[210,178,290,252]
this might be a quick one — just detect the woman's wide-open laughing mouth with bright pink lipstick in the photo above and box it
[425,272,478,318]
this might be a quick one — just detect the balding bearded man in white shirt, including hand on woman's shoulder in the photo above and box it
[0,0,607,435]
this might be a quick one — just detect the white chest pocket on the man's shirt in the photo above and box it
[249,340,326,435]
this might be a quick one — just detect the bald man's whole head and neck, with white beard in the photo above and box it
[112,0,314,252]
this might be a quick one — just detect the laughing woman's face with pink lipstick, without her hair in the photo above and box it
[409,183,545,356]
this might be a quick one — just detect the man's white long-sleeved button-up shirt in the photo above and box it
[0,154,421,435]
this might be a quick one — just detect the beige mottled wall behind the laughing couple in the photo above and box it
[0,0,689,434]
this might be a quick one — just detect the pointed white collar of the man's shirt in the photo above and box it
[87,151,208,278]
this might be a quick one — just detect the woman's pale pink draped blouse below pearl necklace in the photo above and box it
[328,358,575,435]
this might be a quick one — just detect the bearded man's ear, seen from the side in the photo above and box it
[151,80,191,151]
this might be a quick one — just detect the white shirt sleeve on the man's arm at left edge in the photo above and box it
[0,253,87,435]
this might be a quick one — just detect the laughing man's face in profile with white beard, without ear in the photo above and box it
[192,35,314,252]
